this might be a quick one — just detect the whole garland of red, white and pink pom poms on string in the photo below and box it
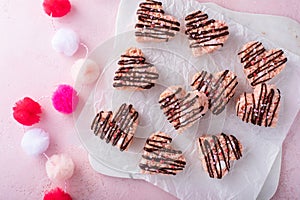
[13,0,100,200]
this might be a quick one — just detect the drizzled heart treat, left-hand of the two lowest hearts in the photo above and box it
[139,132,186,175]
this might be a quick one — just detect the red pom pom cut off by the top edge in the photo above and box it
[43,0,71,17]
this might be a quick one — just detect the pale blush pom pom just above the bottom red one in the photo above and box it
[46,154,74,181]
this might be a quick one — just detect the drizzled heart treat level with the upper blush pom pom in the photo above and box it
[113,48,159,90]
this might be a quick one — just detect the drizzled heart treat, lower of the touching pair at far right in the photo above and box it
[236,83,280,127]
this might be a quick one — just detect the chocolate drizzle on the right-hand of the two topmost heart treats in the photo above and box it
[185,10,229,48]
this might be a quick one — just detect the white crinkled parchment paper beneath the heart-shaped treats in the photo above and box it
[76,0,300,199]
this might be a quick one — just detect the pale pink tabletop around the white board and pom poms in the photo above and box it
[0,0,300,200]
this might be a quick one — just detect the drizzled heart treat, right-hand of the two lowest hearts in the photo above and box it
[198,133,243,179]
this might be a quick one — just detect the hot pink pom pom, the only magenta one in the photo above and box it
[52,85,79,114]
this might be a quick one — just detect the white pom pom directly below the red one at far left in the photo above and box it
[21,128,49,156]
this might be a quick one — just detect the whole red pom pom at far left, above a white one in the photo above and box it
[13,97,42,126]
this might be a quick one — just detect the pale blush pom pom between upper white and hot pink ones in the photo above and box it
[71,59,100,84]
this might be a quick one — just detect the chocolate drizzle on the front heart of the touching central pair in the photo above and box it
[159,87,204,130]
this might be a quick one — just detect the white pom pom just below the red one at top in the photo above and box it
[52,28,79,56]
